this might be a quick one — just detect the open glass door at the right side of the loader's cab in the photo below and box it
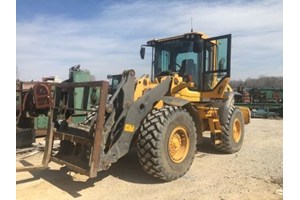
[202,35,231,90]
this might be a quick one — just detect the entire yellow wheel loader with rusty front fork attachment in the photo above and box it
[17,32,250,181]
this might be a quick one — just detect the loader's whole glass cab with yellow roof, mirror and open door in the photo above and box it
[141,32,231,91]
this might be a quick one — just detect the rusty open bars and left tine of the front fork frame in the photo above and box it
[16,81,108,178]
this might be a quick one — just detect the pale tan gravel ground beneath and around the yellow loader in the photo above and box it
[16,119,283,200]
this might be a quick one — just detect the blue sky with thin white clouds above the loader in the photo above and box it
[16,0,283,80]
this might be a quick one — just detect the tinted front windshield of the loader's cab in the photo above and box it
[154,39,201,84]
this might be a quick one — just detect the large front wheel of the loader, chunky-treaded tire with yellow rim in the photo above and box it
[137,106,197,181]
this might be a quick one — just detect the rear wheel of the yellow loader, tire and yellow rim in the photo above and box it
[212,106,244,153]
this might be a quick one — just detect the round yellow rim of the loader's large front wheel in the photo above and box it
[168,127,190,163]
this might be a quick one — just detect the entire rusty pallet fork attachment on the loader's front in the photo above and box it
[16,81,109,178]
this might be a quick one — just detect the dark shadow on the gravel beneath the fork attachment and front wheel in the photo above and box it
[16,151,164,198]
